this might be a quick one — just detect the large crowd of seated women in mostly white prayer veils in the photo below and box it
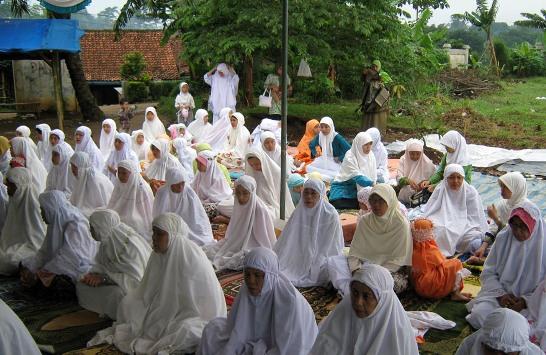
[0,108,546,354]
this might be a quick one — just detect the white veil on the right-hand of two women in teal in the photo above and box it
[334,132,377,183]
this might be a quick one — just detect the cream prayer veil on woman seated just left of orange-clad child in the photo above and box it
[349,184,413,267]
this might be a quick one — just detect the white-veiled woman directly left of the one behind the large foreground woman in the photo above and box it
[108,160,154,242]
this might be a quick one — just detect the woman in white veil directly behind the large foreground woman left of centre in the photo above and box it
[153,168,215,246]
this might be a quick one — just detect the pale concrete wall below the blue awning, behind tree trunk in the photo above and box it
[13,60,78,112]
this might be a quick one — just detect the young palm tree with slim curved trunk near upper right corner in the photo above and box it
[453,0,500,75]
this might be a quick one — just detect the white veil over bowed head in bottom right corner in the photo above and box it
[456,308,544,355]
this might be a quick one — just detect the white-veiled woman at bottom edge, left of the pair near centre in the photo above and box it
[197,247,316,355]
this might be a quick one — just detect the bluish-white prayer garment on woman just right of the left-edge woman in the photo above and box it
[23,191,98,282]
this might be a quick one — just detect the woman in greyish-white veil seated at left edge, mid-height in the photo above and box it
[0,168,46,275]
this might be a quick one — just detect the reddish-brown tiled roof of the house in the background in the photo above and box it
[80,30,189,81]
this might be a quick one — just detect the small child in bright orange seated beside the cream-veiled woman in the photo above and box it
[411,219,463,298]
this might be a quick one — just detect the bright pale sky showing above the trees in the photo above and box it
[87,0,546,25]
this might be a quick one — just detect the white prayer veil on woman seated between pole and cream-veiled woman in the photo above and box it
[274,179,344,287]
